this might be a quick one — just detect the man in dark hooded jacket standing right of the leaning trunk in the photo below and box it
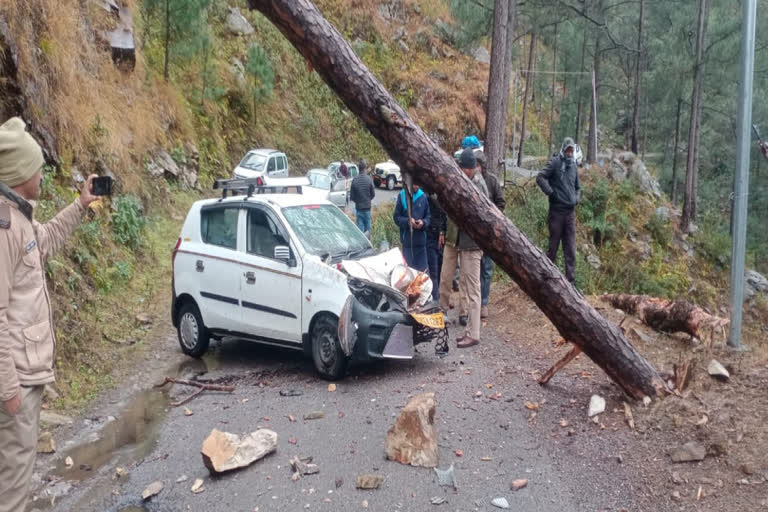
[536,137,581,284]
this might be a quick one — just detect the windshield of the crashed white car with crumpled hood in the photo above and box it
[283,204,371,259]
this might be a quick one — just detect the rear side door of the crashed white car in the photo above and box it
[195,203,242,331]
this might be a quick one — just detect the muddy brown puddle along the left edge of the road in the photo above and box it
[53,390,168,481]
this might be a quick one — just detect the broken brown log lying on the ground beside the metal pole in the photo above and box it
[602,293,729,339]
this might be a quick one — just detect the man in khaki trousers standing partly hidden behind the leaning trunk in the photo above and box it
[440,148,488,348]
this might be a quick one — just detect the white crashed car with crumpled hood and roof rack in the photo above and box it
[171,178,440,379]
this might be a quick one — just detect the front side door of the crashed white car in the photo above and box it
[240,205,302,344]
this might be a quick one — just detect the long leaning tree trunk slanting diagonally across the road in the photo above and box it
[248,0,667,399]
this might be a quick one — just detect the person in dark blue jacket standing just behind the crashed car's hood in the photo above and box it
[393,184,430,272]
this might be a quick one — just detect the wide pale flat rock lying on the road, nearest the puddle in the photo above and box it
[201,428,277,473]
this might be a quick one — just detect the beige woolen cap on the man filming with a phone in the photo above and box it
[0,117,45,187]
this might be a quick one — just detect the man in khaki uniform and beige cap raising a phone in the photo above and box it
[0,117,96,512]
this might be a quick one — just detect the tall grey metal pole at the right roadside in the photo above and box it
[728,0,757,350]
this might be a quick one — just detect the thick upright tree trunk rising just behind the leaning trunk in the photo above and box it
[484,0,512,176]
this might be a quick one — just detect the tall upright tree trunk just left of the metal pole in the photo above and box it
[680,0,707,233]
